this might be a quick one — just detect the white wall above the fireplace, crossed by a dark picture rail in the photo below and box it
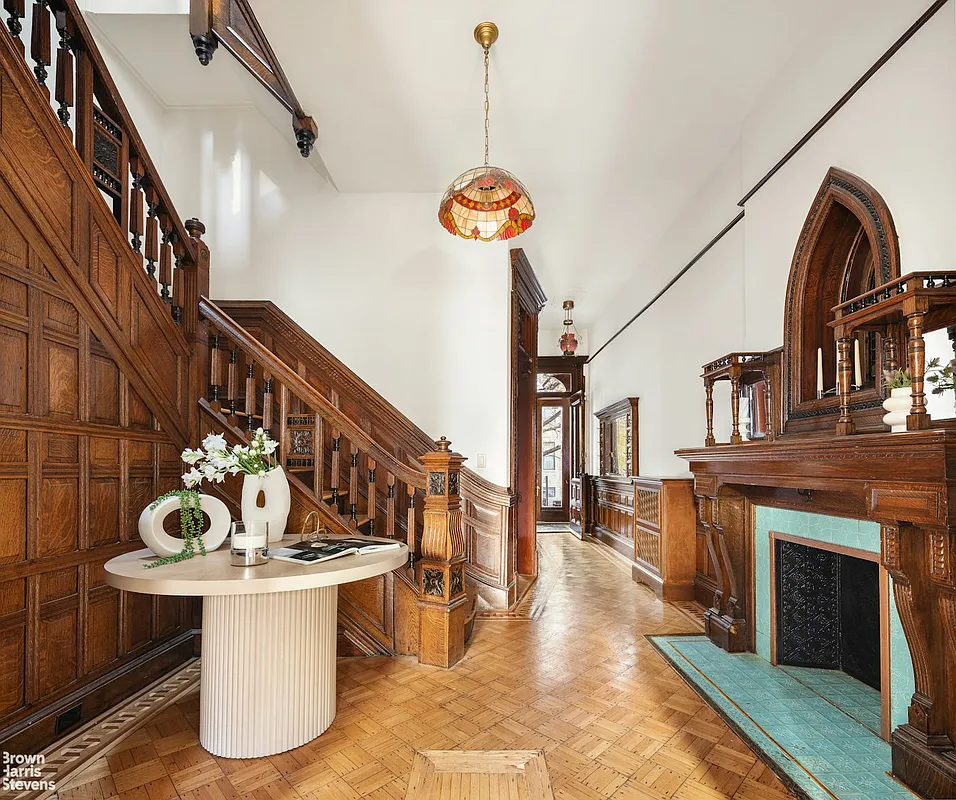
[588,6,956,475]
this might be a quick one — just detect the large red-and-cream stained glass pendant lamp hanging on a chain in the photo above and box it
[438,22,534,242]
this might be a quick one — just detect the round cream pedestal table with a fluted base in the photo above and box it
[106,539,408,758]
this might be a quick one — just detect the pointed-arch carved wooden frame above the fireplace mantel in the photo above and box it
[783,167,900,433]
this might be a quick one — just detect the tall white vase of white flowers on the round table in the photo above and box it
[182,428,291,542]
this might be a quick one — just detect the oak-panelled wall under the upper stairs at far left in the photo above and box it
[0,31,193,752]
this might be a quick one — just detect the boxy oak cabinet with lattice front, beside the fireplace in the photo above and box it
[631,478,697,600]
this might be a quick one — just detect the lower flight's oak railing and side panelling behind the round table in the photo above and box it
[199,298,477,655]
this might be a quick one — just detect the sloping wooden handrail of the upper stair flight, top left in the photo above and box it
[49,0,198,264]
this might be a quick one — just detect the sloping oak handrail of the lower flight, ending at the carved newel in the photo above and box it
[199,297,425,489]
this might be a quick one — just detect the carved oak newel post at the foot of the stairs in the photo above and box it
[417,436,468,667]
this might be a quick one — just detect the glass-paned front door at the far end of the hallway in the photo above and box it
[538,397,571,522]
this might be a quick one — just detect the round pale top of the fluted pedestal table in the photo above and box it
[104,537,408,597]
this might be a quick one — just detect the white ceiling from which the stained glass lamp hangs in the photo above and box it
[84,0,904,327]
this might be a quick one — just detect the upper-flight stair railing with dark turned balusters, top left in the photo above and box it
[0,0,201,332]
